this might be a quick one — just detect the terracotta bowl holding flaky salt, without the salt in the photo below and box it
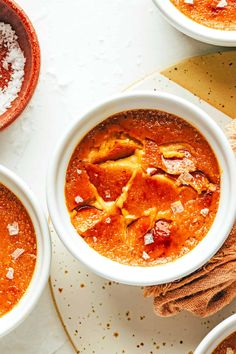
[0,0,40,130]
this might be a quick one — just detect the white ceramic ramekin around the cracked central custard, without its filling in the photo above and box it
[47,91,236,285]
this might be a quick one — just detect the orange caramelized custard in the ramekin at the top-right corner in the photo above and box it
[171,0,236,31]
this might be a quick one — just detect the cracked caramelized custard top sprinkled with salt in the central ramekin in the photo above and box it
[65,110,220,266]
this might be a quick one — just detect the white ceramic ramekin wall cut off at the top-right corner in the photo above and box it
[153,0,236,47]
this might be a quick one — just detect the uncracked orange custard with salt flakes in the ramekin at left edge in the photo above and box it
[0,184,37,316]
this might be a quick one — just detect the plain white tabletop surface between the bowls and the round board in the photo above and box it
[0,0,216,354]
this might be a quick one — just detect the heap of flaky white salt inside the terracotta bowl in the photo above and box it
[0,22,26,114]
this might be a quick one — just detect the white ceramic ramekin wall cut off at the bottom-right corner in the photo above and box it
[194,315,236,354]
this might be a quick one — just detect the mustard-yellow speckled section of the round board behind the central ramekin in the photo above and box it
[161,51,236,118]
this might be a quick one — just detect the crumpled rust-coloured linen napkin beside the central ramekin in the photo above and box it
[144,121,236,317]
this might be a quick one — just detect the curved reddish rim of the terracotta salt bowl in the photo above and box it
[0,0,41,131]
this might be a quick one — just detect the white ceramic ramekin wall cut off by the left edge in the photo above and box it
[0,165,51,337]
